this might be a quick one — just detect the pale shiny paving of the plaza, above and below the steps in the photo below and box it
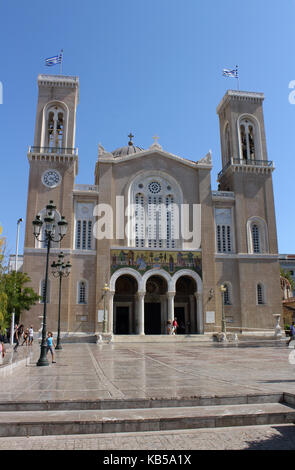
[0,340,295,450]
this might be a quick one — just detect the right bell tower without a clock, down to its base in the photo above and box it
[217,90,281,329]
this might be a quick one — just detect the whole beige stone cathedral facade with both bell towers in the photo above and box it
[21,75,282,336]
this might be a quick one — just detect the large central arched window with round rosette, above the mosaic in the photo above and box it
[129,172,182,249]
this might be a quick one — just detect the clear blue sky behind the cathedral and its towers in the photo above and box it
[0,0,295,253]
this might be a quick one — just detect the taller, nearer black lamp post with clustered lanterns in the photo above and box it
[32,201,68,366]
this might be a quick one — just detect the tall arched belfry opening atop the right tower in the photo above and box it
[239,117,261,161]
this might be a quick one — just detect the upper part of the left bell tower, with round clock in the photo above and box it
[25,75,79,249]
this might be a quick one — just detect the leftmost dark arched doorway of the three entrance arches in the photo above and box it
[113,274,138,335]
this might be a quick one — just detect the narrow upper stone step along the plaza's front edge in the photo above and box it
[0,393,284,412]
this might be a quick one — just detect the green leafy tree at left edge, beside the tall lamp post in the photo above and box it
[0,271,40,322]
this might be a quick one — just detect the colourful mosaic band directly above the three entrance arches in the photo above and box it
[111,250,202,276]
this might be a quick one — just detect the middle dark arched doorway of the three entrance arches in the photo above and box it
[144,275,168,335]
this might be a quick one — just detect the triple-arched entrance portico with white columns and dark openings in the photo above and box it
[107,268,204,335]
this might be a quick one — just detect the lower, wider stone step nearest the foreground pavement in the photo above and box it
[0,403,295,437]
